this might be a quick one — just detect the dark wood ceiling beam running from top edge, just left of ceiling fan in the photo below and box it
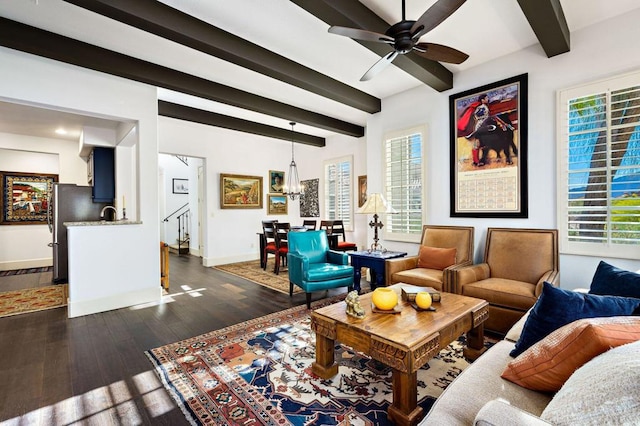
[60,0,381,114]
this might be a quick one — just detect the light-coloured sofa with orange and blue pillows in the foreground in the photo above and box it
[420,315,640,426]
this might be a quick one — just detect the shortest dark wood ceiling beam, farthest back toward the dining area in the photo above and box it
[158,101,326,147]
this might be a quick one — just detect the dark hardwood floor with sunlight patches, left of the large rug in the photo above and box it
[0,255,356,425]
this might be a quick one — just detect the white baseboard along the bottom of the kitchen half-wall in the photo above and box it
[67,286,162,318]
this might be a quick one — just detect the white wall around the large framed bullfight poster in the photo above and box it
[367,11,640,288]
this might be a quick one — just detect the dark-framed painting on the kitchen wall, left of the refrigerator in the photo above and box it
[0,172,58,225]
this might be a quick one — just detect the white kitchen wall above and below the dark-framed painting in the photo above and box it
[0,133,87,270]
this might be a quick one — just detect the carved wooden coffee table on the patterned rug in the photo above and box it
[311,284,489,425]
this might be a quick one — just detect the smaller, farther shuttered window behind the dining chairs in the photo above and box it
[324,156,353,230]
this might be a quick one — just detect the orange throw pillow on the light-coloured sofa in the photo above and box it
[501,316,640,392]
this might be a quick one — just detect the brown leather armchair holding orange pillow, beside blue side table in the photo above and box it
[385,225,474,292]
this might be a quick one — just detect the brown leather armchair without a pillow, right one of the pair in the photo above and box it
[451,228,560,334]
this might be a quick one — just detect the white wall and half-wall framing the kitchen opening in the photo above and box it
[0,48,161,313]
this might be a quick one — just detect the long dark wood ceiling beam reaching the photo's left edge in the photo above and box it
[0,17,364,137]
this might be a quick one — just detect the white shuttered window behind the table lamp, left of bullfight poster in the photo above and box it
[383,128,425,241]
